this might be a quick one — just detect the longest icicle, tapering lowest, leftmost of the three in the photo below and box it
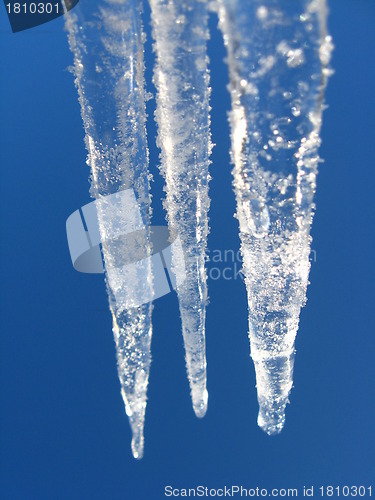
[66,0,152,458]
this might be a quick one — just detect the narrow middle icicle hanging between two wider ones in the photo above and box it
[149,0,211,417]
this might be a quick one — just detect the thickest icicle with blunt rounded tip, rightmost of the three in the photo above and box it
[218,0,332,434]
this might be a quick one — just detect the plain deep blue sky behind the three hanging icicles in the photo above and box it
[0,0,375,500]
